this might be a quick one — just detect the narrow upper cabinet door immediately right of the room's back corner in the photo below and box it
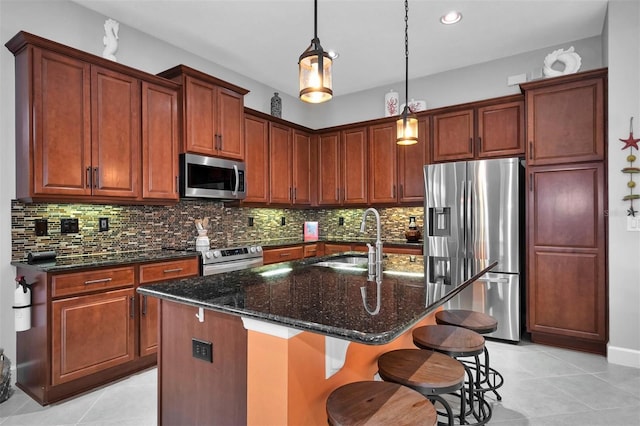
[318,132,340,206]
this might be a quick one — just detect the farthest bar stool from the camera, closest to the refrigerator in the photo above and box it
[436,309,504,401]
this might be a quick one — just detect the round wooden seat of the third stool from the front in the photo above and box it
[413,325,484,357]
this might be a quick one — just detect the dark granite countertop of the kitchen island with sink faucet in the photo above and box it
[137,252,496,345]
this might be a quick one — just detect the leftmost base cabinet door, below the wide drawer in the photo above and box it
[51,288,135,385]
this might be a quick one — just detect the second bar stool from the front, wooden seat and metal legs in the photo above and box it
[378,349,466,426]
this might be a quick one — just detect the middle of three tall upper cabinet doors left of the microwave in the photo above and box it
[91,66,140,198]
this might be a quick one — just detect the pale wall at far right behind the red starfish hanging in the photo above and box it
[603,0,640,367]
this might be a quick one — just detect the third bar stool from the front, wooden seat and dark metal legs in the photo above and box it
[412,325,491,425]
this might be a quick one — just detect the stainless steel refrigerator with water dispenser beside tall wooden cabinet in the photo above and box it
[424,158,524,342]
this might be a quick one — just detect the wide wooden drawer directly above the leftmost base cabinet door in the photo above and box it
[51,266,135,297]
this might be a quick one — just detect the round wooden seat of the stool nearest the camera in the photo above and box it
[327,381,438,426]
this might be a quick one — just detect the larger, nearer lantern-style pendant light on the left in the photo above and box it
[298,0,333,104]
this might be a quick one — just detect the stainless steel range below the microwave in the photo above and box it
[201,246,263,275]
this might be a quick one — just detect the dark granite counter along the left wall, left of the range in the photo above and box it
[11,250,200,272]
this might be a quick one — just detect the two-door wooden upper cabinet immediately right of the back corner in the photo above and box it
[318,127,368,206]
